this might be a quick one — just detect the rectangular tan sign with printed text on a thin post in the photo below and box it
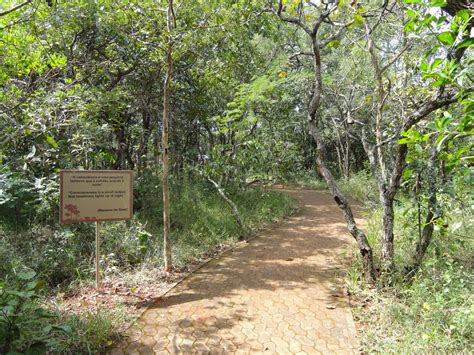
[59,170,133,289]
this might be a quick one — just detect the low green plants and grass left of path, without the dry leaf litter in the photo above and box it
[0,175,297,353]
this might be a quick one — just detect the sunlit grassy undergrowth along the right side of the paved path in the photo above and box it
[342,173,474,354]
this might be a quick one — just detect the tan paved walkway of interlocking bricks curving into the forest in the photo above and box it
[111,190,358,354]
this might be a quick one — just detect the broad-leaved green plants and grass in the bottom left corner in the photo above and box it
[0,271,123,354]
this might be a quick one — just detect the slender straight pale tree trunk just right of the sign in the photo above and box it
[161,0,175,271]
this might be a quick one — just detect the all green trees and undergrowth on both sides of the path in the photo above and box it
[0,0,474,352]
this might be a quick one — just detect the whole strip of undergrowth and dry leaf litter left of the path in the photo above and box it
[0,174,297,353]
